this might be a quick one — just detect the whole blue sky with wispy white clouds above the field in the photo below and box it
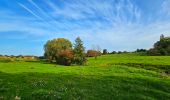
[0,0,170,55]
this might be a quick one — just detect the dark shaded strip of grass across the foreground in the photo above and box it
[0,72,170,100]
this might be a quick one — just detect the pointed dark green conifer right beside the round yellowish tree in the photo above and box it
[73,37,86,65]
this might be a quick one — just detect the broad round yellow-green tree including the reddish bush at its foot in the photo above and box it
[44,38,72,65]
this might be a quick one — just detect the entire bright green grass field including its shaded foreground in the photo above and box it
[0,54,170,100]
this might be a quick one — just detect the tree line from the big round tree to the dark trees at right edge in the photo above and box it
[44,35,170,65]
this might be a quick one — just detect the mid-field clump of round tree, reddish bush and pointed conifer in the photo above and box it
[44,37,86,65]
